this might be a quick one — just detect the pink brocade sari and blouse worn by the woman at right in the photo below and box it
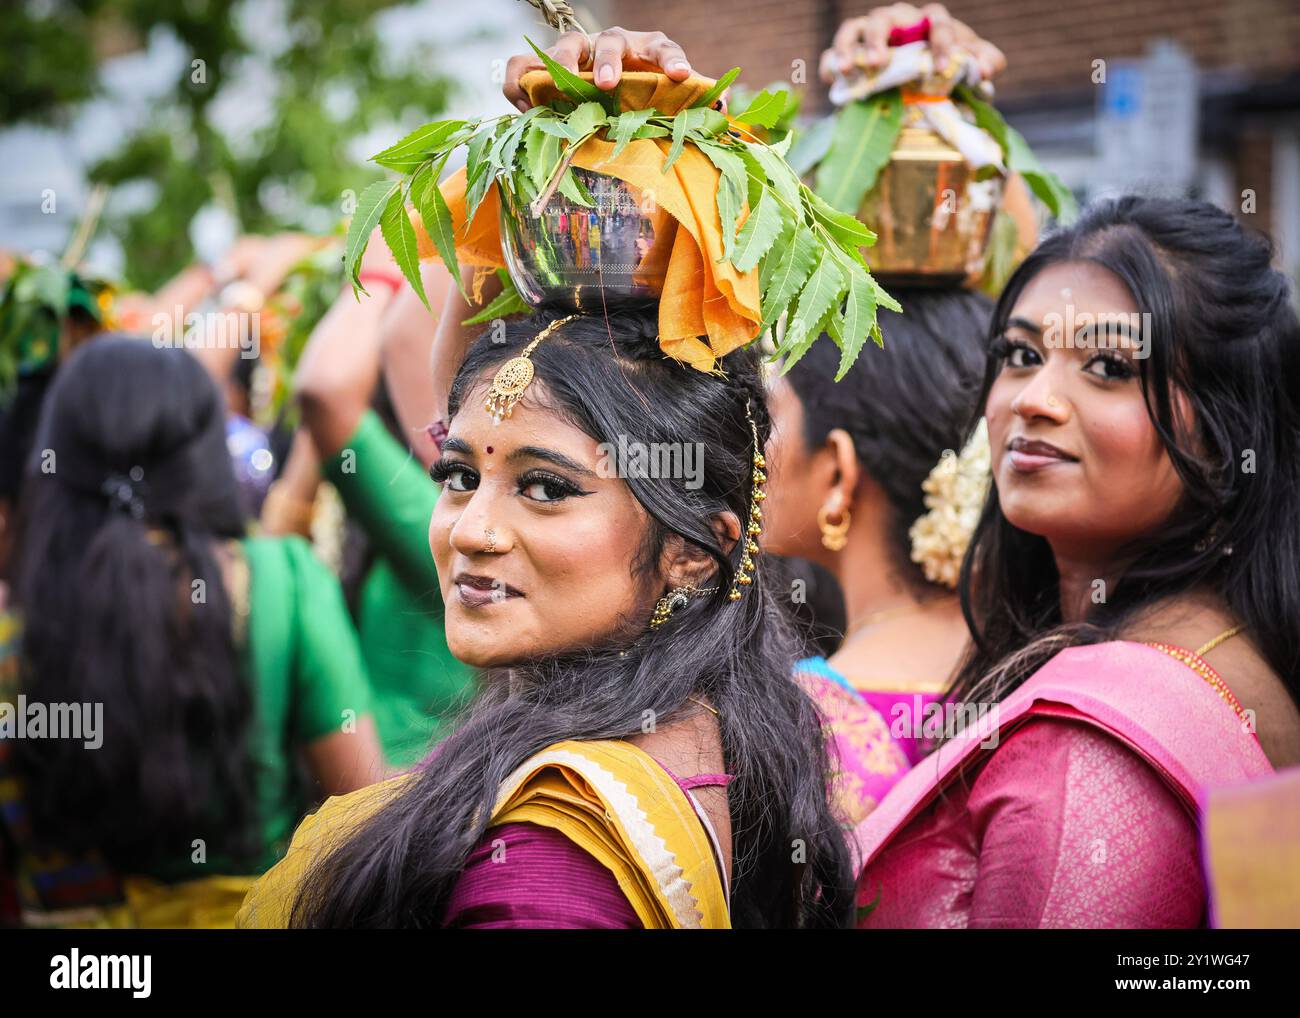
[855,641,1273,927]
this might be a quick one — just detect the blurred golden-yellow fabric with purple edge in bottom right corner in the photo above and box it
[1203,767,1300,930]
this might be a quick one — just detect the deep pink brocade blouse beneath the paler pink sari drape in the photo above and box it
[858,718,1205,928]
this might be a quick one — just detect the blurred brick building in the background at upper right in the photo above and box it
[589,0,1300,280]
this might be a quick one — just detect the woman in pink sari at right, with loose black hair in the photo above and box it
[857,198,1300,927]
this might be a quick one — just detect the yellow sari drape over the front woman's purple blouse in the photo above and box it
[235,741,731,930]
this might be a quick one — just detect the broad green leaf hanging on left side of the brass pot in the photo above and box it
[815,88,902,215]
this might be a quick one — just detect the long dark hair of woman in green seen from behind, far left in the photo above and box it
[14,335,255,872]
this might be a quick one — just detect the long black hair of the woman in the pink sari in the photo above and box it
[952,196,1300,702]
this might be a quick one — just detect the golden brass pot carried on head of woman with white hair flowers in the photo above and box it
[858,125,1002,286]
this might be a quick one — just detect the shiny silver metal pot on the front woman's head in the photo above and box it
[501,168,677,311]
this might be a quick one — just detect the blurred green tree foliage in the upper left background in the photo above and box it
[0,0,454,290]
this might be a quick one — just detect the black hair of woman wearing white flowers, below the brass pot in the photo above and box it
[785,287,993,595]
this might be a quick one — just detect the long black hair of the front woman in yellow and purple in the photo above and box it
[293,312,853,927]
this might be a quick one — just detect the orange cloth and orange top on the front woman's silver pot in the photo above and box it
[415,70,763,371]
